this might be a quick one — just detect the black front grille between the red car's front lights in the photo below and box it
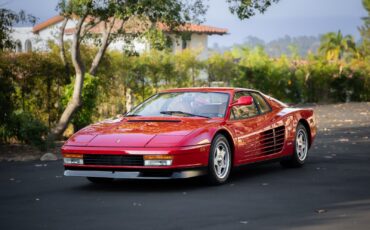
[84,154,144,166]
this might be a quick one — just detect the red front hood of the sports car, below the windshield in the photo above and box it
[65,117,217,147]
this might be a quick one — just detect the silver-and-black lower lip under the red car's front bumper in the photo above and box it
[64,168,207,180]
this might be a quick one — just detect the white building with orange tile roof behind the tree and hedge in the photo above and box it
[12,15,227,59]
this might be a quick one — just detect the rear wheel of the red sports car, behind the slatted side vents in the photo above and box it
[280,123,309,168]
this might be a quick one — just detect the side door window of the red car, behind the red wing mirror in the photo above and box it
[230,92,259,120]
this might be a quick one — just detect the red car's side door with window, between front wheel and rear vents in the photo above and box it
[227,91,264,163]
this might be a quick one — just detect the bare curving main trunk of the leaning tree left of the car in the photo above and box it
[48,16,86,141]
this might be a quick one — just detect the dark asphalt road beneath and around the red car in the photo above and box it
[0,103,370,230]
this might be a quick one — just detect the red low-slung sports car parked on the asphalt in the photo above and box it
[62,88,316,184]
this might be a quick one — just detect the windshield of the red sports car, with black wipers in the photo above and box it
[126,92,229,117]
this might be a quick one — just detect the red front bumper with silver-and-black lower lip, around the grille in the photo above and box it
[62,144,210,179]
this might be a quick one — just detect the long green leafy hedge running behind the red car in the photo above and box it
[0,46,370,148]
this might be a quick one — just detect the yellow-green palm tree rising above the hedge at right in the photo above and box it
[319,30,357,60]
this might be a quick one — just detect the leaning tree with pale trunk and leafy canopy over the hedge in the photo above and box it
[49,0,278,139]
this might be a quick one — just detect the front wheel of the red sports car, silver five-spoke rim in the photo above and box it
[207,134,232,185]
